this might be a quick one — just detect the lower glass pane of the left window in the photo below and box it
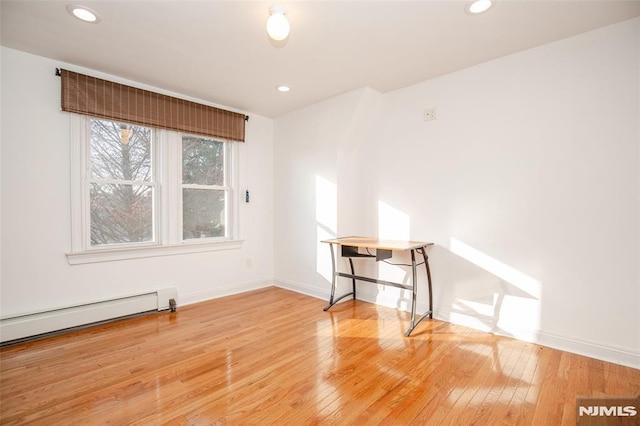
[90,183,153,246]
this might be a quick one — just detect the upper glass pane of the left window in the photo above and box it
[90,119,151,181]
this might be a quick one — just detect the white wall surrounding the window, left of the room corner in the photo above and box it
[0,48,273,316]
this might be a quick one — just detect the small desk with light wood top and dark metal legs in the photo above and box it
[322,237,433,336]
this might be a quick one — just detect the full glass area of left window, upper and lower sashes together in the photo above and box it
[87,118,156,247]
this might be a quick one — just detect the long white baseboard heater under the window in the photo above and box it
[0,287,177,345]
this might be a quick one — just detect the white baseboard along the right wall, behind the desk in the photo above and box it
[273,279,640,369]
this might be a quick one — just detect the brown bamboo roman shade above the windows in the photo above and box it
[61,70,245,142]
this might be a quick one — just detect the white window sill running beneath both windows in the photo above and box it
[66,240,244,265]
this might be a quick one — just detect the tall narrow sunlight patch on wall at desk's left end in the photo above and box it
[316,176,338,282]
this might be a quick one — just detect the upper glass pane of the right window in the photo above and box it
[182,136,224,186]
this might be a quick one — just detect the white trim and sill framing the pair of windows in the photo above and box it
[66,114,244,265]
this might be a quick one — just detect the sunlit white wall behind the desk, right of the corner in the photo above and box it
[274,19,640,367]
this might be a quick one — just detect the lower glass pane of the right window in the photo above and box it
[182,188,225,240]
